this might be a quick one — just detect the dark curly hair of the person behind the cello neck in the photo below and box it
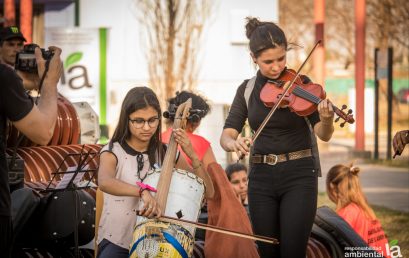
[165,91,210,122]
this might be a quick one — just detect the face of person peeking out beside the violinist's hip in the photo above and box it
[226,163,248,206]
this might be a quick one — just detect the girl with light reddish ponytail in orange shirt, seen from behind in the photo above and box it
[326,164,390,258]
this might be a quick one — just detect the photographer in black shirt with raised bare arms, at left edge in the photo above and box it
[0,47,63,257]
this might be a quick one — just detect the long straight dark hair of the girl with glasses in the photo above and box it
[111,87,164,166]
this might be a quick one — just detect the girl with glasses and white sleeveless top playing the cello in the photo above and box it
[97,87,213,257]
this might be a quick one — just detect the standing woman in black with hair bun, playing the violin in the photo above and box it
[220,18,334,258]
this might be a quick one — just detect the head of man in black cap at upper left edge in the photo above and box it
[0,26,26,69]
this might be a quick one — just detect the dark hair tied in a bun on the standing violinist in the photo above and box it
[246,17,288,58]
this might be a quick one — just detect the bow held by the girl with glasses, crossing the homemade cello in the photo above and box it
[136,211,279,244]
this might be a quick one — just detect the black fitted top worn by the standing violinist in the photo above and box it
[224,72,320,154]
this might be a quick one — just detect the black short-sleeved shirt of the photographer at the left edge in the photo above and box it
[0,64,33,216]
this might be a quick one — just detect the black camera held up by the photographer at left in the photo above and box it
[14,44,54,73]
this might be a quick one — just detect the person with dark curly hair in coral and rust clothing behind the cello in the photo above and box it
[162,91,259,258]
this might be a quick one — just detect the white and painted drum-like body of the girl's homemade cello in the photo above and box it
[130,169,205,258]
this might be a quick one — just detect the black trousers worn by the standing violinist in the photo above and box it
[248,157,318,258]
